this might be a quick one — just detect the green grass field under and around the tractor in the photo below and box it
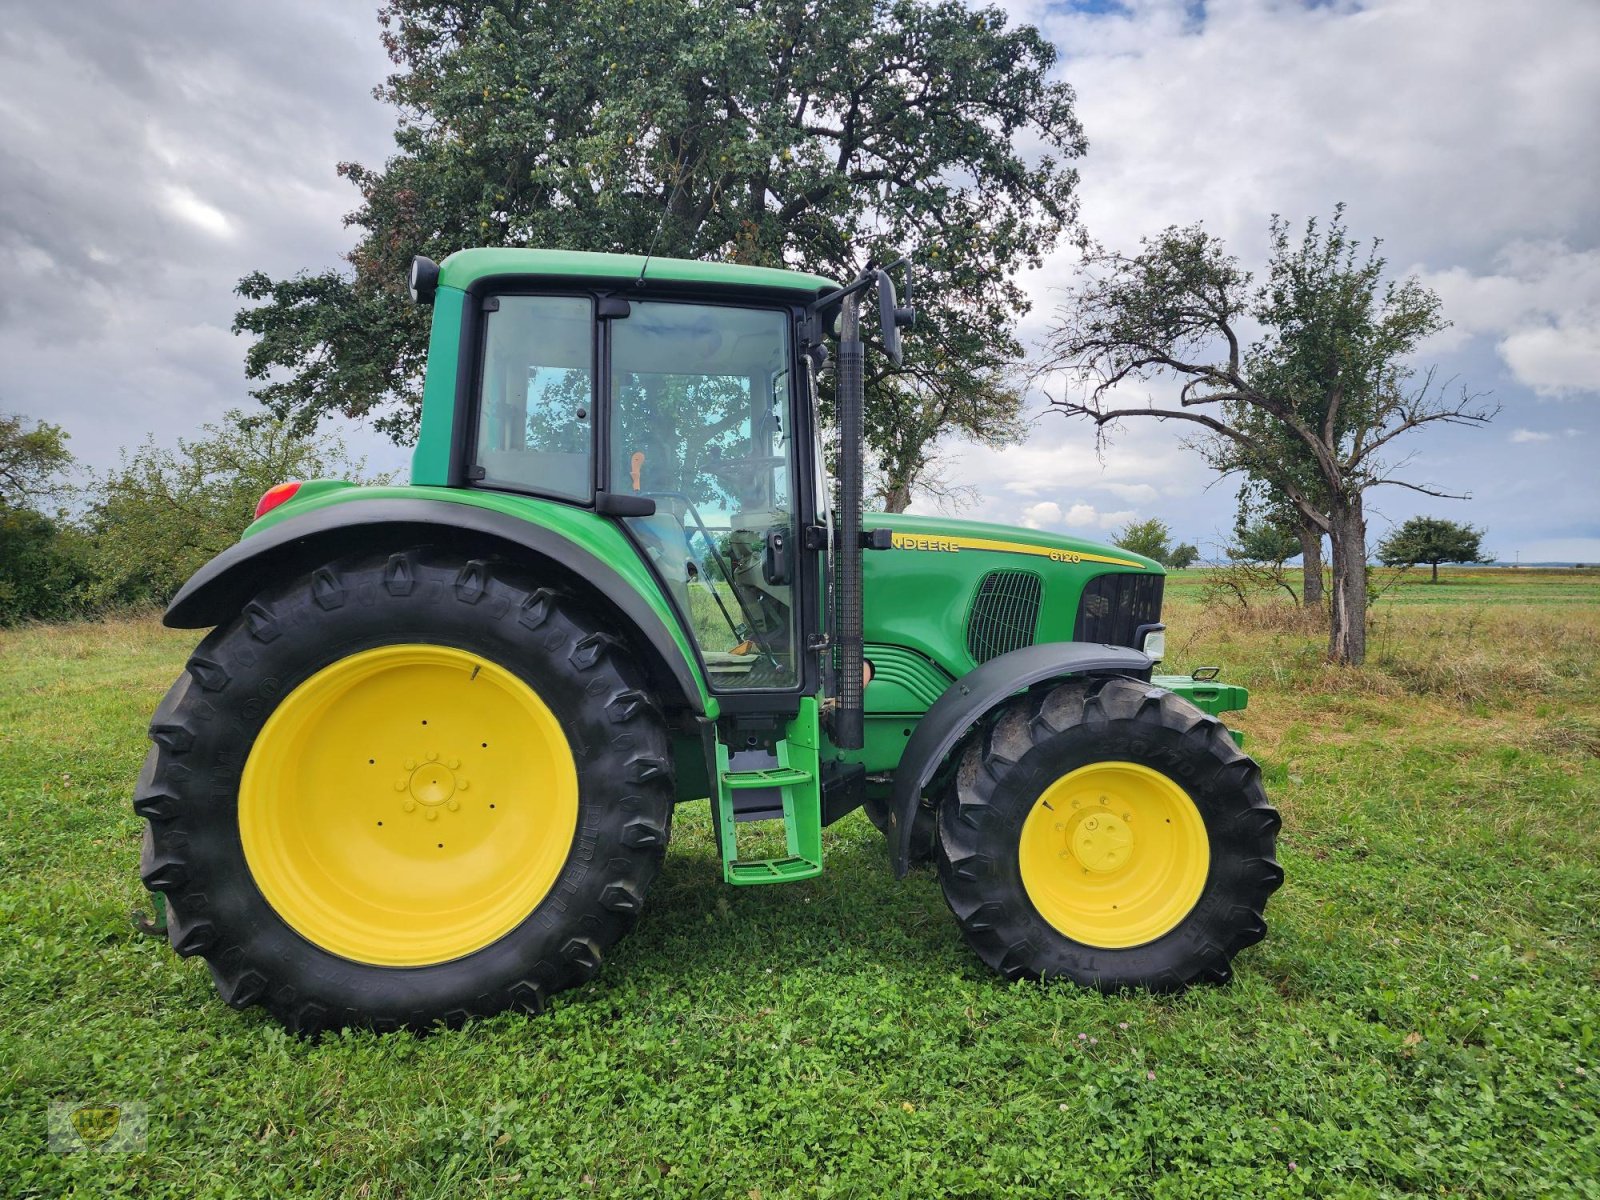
[0,571,1600,1200]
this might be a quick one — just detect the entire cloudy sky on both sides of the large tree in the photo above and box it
[0,0,1600,562]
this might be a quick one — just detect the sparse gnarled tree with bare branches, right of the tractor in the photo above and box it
[1050,205,1493,664]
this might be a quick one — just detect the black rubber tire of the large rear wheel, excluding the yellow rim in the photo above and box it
[133,546,674,1035]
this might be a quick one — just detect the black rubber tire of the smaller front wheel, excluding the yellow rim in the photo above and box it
[936,678,1283,992]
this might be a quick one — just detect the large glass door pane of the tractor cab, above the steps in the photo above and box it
[610,301,798,690]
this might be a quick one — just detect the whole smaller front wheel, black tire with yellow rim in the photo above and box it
[938,678,1283,992]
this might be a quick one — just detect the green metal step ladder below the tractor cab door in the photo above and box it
[717,696,822,886]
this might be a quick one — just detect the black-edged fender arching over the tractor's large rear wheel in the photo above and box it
[162,494,714,715]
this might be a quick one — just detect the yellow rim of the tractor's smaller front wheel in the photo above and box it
[1018,762,1211,949]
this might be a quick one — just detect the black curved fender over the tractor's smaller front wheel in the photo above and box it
[888,642,1150,878]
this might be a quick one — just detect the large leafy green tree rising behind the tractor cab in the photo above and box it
[235,0,1085,507]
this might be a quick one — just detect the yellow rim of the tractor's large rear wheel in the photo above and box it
[238,645,578,966]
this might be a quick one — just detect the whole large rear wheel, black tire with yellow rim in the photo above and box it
[134,547,672,1032]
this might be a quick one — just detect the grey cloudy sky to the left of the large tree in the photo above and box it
[0,0,395,467]
